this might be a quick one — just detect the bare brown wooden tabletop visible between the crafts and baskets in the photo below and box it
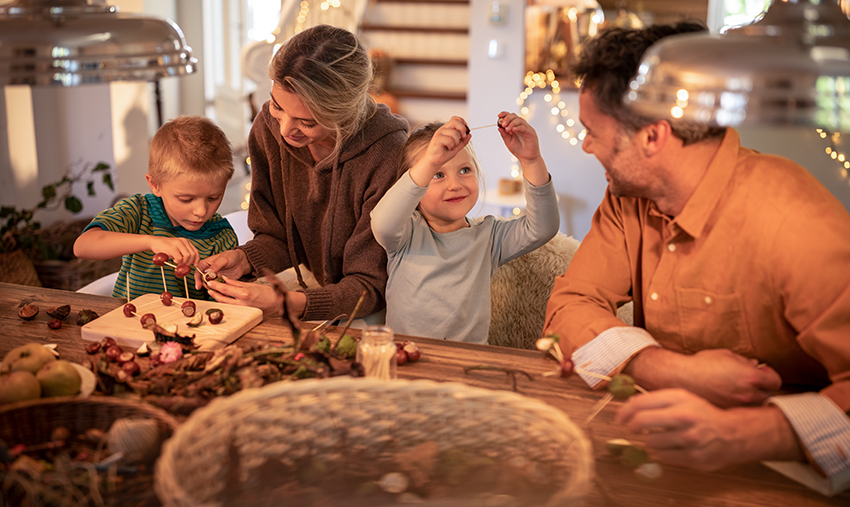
[0,283,850,507]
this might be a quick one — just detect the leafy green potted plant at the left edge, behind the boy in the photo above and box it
[0,162,114,286]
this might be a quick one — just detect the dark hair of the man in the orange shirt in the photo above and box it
[572,21,726,145]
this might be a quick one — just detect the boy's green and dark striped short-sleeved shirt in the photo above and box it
[83,194,238,300]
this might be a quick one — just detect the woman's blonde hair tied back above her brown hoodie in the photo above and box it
[269,25,377,164]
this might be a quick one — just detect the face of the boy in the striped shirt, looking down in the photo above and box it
[145,174,227,231]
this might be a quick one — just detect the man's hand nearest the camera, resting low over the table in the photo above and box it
[615,389,804,472]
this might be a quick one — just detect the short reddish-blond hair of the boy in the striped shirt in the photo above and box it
[148,116,233,185]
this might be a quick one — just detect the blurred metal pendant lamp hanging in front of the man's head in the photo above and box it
[624,0,850,131]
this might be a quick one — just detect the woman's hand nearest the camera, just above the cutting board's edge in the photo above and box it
[204,277,307,317]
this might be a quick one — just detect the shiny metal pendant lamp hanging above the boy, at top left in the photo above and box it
[0,0,197,86]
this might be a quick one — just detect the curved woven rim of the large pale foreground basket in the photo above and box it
[154,377,594,506]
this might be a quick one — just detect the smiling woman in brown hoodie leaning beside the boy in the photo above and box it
[196,25,408,320]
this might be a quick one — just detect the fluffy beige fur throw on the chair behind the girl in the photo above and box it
[488,234,633,349]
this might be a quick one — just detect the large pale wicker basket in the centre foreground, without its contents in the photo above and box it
[154,377,593,507]
